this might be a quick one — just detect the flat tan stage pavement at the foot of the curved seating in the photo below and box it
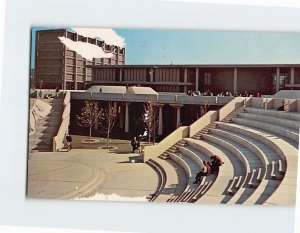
[27,136,159,201]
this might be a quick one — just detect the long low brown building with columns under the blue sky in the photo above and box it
[88,64,300,94]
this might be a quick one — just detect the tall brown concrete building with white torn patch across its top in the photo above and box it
[35,29,125,90]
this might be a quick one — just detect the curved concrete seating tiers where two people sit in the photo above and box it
[145,97,300,205]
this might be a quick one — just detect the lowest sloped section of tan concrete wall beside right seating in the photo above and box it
[143,126,189,162]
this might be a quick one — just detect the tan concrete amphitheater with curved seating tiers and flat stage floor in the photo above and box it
[27,92,300,205]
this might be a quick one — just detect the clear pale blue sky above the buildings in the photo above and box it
[31,28,300,67]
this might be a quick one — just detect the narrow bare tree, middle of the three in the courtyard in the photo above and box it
[100,102,117,148]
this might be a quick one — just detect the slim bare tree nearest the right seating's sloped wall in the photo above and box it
[143,102,158,144]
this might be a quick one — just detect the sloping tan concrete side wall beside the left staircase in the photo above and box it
[53,91,71,151]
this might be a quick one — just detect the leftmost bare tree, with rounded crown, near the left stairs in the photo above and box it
[77,101,103,141]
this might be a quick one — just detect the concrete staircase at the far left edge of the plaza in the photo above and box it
[29,99,63,152]
